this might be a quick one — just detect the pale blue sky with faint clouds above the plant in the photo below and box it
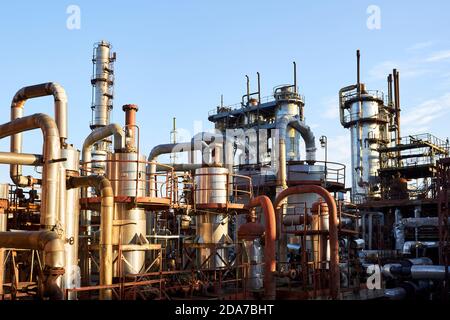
[0,0,450,182]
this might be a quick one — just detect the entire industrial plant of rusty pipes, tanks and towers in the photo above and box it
[0,41,450,300]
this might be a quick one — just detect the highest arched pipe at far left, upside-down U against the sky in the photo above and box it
[10,82,67,187]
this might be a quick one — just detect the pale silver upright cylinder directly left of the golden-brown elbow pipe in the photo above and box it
[61,146,81,300]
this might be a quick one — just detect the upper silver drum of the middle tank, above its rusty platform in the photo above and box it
[194,167,230,205]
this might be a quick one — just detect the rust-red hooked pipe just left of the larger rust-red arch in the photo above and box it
[245,196,277,300]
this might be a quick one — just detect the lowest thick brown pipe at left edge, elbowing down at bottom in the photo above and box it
[0,231,65,300]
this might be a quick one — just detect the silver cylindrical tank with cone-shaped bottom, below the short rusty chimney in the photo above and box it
[107,153,147,276]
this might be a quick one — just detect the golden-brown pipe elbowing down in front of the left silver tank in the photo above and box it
[67,175,114,300]
